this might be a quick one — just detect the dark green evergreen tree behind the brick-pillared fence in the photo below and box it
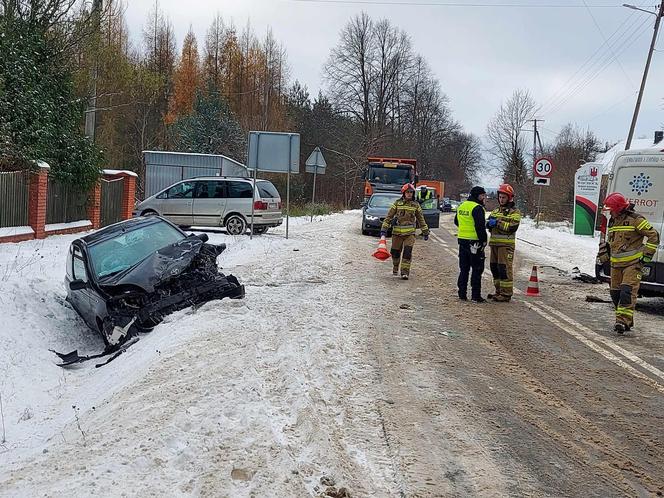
[0,16,102,188]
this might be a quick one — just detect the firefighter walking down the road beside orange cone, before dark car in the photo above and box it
[380,183,429,280]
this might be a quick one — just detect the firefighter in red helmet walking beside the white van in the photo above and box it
[597,192,659,334]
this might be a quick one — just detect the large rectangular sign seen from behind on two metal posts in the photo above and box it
[247,131,300,238]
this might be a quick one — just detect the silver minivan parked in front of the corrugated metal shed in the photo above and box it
[133,176,283,235]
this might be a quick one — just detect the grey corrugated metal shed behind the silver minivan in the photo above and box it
[143,151,249,198]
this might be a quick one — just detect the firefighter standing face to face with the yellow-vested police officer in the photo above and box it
[486,183,521,303]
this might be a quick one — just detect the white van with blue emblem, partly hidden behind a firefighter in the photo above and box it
[602,149,664,296]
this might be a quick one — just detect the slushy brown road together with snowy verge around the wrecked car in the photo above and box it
[0,212,664,497]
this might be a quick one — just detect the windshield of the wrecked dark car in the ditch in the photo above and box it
[89,221,185,278]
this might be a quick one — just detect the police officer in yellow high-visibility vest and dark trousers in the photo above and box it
[454,187,487,303]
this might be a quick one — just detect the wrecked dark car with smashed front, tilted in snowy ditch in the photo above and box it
[65,216,244,349]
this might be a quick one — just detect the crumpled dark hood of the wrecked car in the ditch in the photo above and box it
[100,237,226,292]
